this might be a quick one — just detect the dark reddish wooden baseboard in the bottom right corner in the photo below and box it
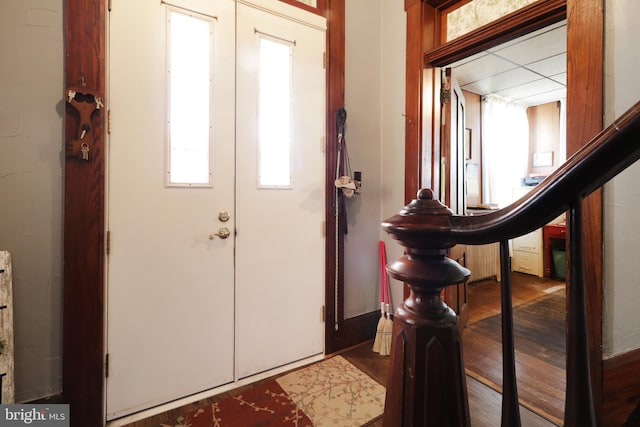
[603,349,640,427]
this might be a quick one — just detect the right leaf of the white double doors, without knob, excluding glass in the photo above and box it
[236,5,325,377]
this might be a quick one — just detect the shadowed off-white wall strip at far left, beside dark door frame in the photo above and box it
[0,0,65,402]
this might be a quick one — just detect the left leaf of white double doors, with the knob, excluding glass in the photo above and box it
[107,0,235,419]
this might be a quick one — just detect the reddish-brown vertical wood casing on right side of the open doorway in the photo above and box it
[567,0,604,425]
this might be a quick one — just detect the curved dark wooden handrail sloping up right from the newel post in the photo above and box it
[382,102,640,247]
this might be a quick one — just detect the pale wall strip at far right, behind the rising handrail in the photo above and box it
[604,0,640,357]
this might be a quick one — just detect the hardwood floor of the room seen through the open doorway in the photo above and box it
[462,273,566,425]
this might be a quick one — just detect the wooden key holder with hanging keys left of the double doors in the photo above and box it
[65,85,104,160]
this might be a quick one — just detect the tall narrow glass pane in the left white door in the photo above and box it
[167,9,213,186]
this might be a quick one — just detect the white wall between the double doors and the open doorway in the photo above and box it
[345,0,406,318]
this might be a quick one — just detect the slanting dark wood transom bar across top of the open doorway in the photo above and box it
[424,0,566,67]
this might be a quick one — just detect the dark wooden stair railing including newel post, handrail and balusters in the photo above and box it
[382,102,640,427]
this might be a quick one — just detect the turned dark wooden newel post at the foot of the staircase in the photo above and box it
[382,189,470,427]
